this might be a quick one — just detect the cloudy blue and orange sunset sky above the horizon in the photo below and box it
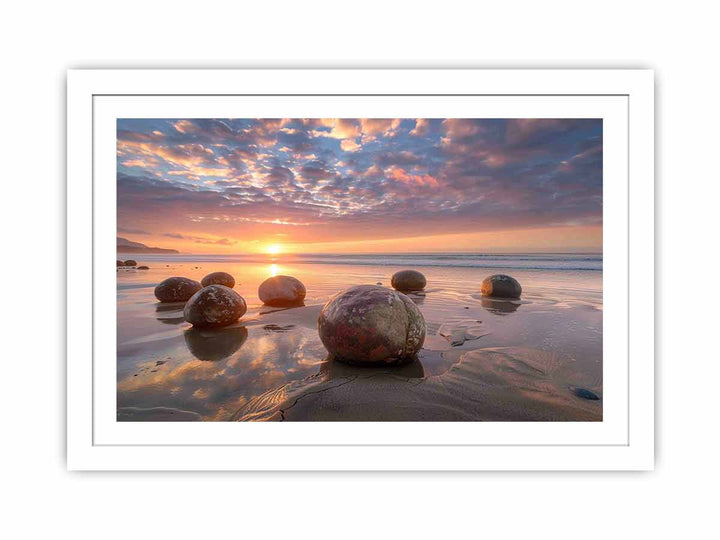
[117,118,603,253]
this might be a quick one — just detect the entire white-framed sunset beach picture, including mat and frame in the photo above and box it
[67,70,654,470]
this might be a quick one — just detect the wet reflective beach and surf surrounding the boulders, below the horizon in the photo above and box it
[117,253,603,421]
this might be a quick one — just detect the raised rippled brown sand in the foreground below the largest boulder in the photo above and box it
[233,347,602,422]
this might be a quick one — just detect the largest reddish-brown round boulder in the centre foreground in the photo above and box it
[318,285,425,364]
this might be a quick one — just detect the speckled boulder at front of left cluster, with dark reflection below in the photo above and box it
[183,285,247,328]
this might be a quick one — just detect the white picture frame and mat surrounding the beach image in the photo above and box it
[67,70,654,471]
